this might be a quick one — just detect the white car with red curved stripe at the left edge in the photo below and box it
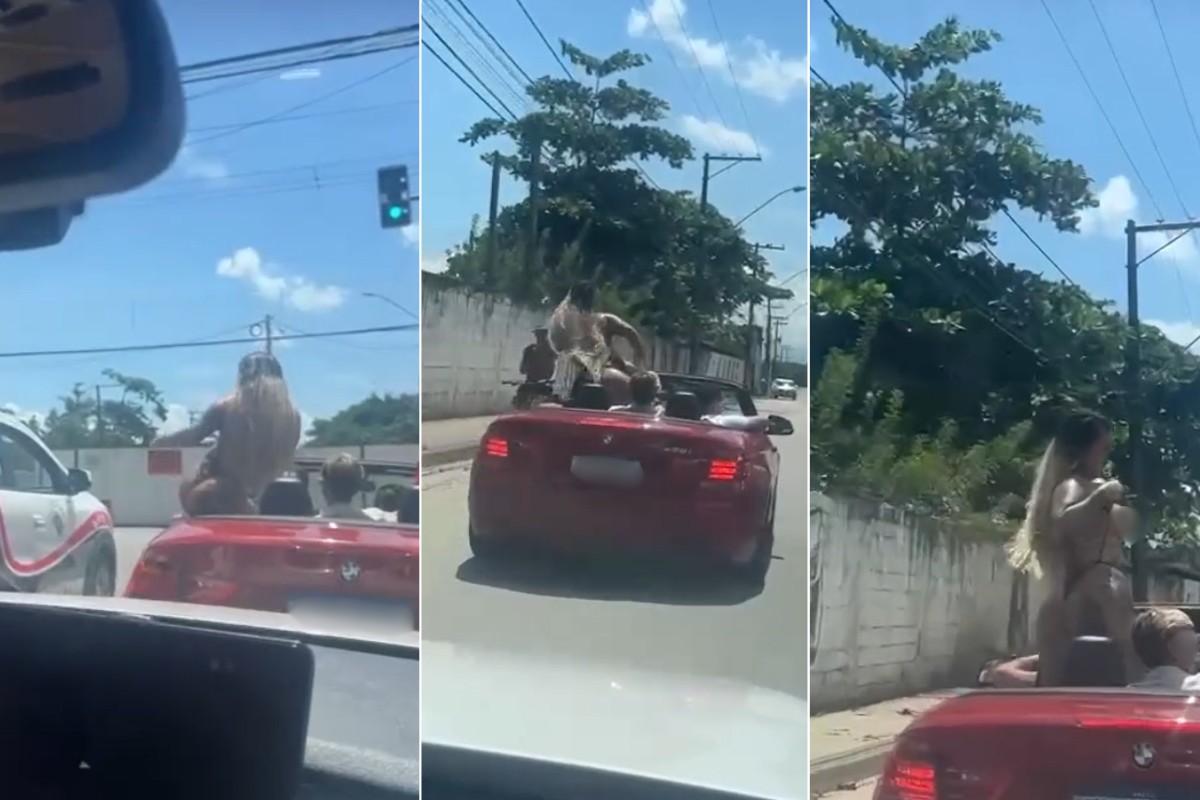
[0,413,116,597]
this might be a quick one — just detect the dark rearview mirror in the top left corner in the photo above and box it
[0,0,184,219]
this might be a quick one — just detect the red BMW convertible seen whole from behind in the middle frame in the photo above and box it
[468,374,793,585]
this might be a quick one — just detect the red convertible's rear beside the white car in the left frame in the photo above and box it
[125,462,420,630]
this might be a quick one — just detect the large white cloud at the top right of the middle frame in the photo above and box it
[625,0,809,103]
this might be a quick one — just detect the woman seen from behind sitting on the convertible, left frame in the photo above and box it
[150,353,300,516]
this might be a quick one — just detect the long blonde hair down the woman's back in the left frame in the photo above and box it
[221,353,301,492]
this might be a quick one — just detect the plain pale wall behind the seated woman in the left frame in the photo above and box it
[54,445,420,527]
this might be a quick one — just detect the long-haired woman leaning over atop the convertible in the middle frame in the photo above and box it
[550,281,646,405]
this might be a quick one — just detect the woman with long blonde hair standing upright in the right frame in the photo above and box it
[1007,411,1145,686]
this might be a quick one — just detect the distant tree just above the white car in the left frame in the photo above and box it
[35,369,167,450]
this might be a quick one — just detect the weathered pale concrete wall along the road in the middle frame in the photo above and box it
[421,273,745,420]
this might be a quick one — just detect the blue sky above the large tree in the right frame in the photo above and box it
[812,0,1200,357]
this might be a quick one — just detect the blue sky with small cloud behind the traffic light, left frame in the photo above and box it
[0,0,420,438]
